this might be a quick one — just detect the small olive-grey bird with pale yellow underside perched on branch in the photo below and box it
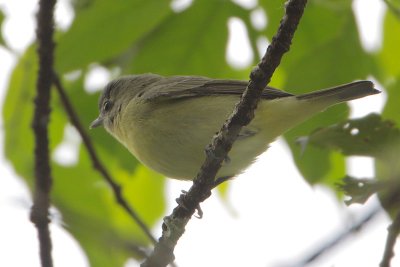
[90,73,380,180]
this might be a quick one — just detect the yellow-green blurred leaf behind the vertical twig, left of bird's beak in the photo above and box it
[3,46,66,185]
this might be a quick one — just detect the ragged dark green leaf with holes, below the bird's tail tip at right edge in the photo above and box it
[307,114,400,214]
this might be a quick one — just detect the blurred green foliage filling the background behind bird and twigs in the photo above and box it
[0,0,400,266]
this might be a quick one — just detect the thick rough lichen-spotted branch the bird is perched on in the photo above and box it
[142,0,307,267]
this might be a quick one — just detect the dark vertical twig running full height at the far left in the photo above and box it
[30,0,56,267]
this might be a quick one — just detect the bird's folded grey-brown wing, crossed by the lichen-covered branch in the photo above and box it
[141,76,292,101]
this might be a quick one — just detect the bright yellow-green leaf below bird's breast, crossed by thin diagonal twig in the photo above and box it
[53,151,165,267]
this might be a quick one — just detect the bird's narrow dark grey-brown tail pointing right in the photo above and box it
[297,81,380,104]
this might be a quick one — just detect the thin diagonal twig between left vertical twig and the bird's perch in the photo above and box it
[53,73,157,244]
